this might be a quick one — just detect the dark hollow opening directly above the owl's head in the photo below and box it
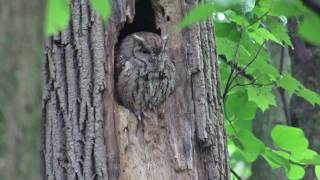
[118,0,161,42]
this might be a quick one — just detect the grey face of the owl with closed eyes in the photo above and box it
[133,35,168,71]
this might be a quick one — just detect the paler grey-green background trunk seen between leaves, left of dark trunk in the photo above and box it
[250,43,291,180]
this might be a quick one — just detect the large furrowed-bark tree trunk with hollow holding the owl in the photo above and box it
[43,0,230,180]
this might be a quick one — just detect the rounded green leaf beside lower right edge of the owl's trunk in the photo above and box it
[235,129,265,162]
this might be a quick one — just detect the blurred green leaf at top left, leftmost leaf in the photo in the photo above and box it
[45,0,70,36]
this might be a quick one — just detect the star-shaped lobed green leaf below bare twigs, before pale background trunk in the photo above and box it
[247,86,277,111]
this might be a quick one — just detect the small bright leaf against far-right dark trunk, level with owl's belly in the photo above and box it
[277,73,302,96]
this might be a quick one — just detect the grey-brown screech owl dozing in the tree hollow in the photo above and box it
[115,32,175,120]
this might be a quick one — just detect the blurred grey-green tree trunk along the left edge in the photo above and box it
[0,0,44,180]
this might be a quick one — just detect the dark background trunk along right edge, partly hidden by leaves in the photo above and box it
[289,19,320,179]
